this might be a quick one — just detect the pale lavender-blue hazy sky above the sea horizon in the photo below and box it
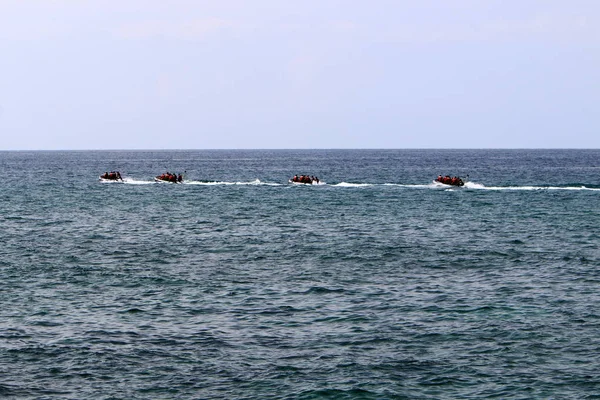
[0,0,600,150]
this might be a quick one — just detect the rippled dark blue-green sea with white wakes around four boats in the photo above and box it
[0,150,600,400]
